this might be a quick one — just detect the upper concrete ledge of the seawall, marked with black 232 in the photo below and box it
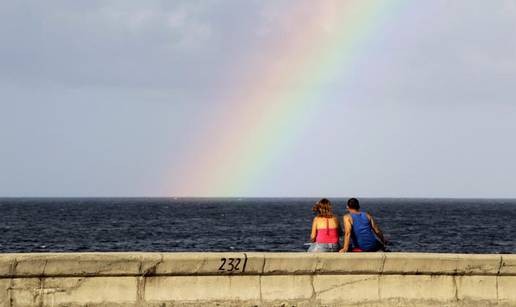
[0,253,516,278]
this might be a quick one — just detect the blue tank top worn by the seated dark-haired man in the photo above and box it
[351,212,379,252]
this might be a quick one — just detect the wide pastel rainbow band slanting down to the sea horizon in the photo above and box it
[168,0,408,197]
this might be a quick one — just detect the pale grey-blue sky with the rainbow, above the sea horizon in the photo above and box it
[0,0,516,198]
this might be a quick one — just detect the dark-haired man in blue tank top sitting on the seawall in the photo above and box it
[339,198,386,253]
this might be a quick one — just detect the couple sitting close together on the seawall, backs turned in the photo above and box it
[308,198,386,253]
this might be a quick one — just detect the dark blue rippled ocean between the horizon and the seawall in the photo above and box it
[0,198,516,253]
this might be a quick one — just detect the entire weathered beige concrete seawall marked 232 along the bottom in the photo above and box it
[0,253,516,306]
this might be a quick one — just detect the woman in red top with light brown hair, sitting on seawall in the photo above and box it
[308,198,341,252]
